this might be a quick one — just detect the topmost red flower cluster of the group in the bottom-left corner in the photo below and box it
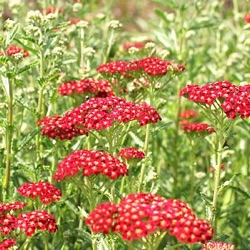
[17,181,62,204]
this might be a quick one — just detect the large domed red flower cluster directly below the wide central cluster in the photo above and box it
[54,150,128,181]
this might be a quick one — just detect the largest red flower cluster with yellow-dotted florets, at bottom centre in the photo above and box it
[86,193,213,244]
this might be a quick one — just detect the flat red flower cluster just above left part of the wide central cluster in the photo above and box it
[57,78,113,97]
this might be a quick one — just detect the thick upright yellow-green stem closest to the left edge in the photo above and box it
[3,79,13,198]
